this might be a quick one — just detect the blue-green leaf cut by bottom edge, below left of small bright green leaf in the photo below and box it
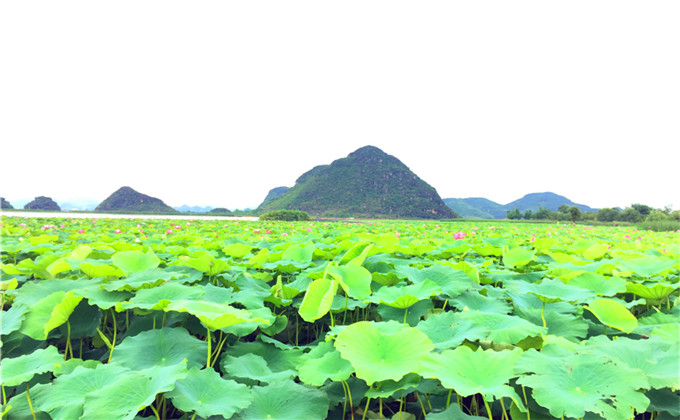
[236,380,328,420]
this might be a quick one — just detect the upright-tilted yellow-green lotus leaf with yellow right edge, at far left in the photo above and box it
[19,291,83,340]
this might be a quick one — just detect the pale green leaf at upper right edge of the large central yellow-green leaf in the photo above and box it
[416,312,489,349]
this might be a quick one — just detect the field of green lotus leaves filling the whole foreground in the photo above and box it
[1,217,680,420]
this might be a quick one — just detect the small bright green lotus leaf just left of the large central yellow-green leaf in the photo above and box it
[298,342,354,386]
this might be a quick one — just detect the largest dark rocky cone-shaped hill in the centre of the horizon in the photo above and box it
[258,146,458,219]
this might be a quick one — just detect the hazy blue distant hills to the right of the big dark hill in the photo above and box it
[444,192,597,219]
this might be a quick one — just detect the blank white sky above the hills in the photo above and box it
[0,0,680,210]
